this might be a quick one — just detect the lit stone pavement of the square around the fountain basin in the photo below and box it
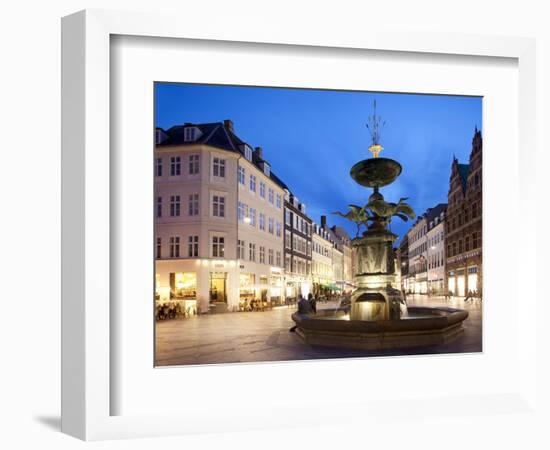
[156,295,482,366]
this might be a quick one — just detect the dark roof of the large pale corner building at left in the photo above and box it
[157,121,289,190]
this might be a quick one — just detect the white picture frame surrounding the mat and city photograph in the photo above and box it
[62,10,537,440]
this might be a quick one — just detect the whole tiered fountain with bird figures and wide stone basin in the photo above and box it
[292,101,468,349]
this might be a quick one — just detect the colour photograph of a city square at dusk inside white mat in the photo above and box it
[151,82,483,367]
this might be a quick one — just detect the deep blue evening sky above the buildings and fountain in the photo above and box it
[155,83,482,241]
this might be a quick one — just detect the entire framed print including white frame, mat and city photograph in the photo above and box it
[62,11,536,439]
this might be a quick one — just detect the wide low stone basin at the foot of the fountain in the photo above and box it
[292,306,468,350]
